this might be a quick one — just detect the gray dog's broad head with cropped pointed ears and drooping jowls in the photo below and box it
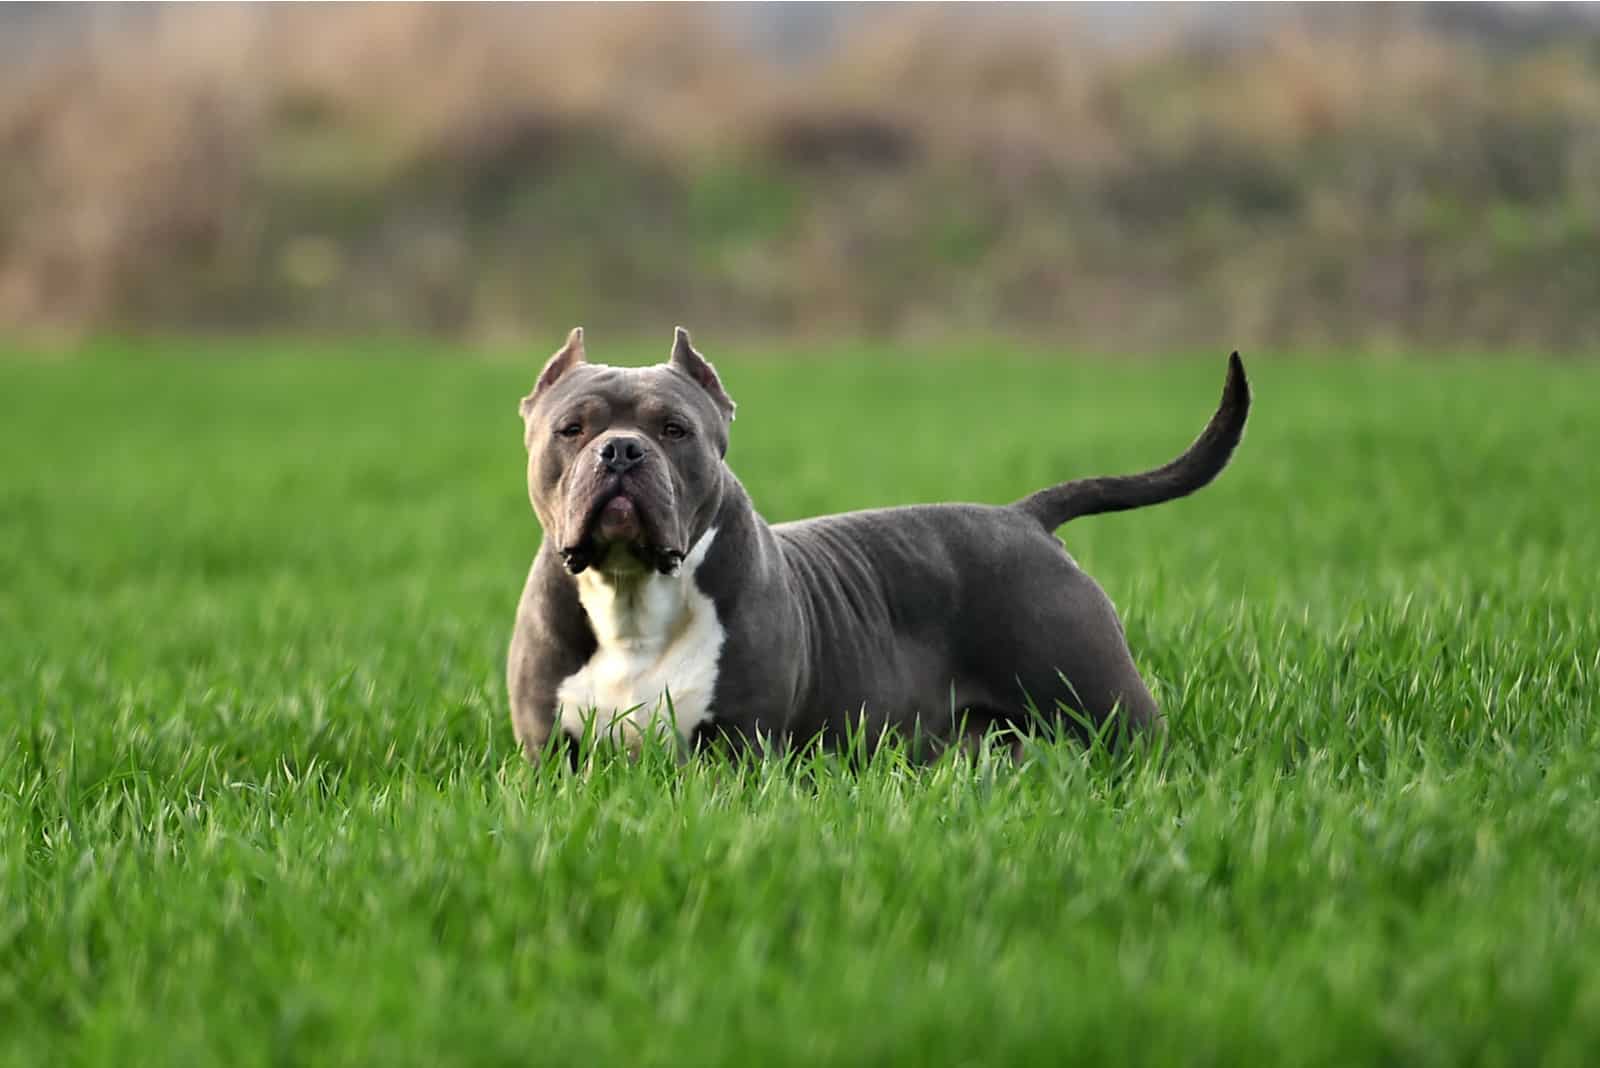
[522,326,734,574]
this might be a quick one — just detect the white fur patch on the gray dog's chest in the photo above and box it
[555,528,725,745]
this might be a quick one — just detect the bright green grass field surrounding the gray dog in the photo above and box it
[0,343,1600,1065]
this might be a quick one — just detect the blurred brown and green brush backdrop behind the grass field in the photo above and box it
[0,3,1600,353]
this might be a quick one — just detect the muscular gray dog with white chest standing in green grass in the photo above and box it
[507,328,1250,756]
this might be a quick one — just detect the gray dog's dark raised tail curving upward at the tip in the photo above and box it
[1011,352,1250,531]
